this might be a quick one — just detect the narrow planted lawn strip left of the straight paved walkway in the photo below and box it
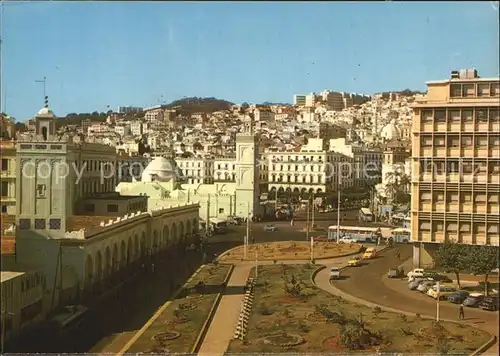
[127,264,231,353]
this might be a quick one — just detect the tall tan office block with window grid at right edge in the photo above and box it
[411,70,500,266]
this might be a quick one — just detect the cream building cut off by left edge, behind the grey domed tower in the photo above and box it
[0,140,16,215]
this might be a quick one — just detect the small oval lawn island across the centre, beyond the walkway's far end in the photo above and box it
[220,241,361,261]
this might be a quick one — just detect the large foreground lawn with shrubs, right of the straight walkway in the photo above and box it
[228,265,490,354]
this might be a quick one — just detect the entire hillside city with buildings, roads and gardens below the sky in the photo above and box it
[0,69,500,355]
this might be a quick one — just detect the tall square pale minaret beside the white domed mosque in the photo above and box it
[236,116,261,217]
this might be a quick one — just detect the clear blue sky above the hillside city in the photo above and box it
[0,1,499,121]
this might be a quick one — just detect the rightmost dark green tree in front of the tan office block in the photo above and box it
[467,245,499,296]
